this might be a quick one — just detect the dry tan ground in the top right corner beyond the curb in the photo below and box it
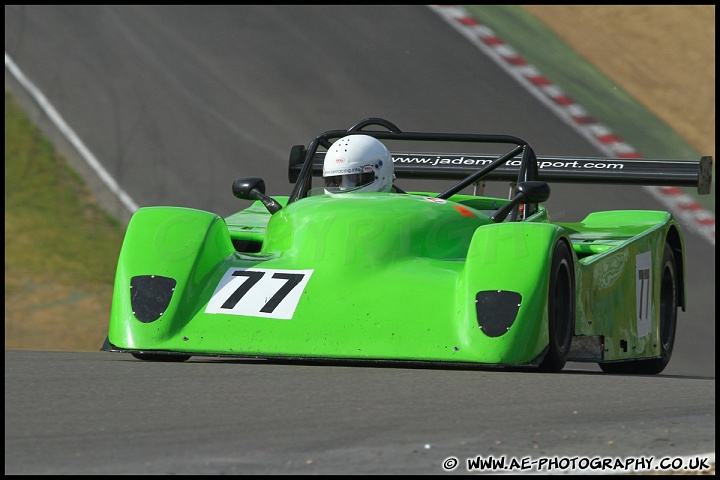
[523,5,715,163]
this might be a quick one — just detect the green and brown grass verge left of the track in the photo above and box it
[5,91,124,351]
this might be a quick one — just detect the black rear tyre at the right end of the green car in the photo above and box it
[599,243,678,375]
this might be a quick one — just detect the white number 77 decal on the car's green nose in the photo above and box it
[205,268,313,320]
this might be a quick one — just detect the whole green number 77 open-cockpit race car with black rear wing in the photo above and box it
[102,118,712,374]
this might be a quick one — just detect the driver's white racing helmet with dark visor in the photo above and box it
[323,135,395,193]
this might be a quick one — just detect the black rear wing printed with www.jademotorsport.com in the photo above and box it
[289,149,712,195]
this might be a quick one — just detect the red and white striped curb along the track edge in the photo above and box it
[428,5,715,247]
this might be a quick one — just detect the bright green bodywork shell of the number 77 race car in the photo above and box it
[107,189,685,365]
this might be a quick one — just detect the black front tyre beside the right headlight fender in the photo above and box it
[539,240,575,372]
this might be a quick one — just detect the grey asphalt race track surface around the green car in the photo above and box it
[5,5,715,474]
